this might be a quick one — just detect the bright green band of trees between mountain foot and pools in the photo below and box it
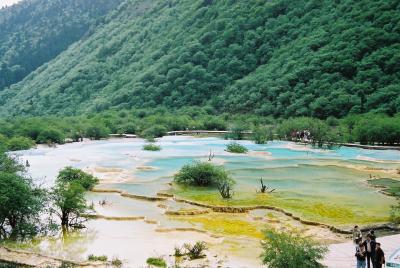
[0,107,400,151]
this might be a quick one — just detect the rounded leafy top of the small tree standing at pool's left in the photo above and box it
[57,167,99,190]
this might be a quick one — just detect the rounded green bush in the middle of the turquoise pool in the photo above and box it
[174,161,233,186]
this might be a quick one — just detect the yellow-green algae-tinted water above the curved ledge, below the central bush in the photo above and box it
[170,179,394,226]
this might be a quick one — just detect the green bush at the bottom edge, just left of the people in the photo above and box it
[261,231,327,268]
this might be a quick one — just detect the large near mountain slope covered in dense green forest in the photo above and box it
[0,0,400,118]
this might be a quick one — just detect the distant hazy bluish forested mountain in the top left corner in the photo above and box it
[0,0,121,90]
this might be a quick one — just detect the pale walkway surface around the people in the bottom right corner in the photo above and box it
[322,234,400,268]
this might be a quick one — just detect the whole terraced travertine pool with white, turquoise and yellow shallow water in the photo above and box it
[8,136,400,267]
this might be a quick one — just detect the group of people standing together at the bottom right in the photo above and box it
[353,225,385,268]
